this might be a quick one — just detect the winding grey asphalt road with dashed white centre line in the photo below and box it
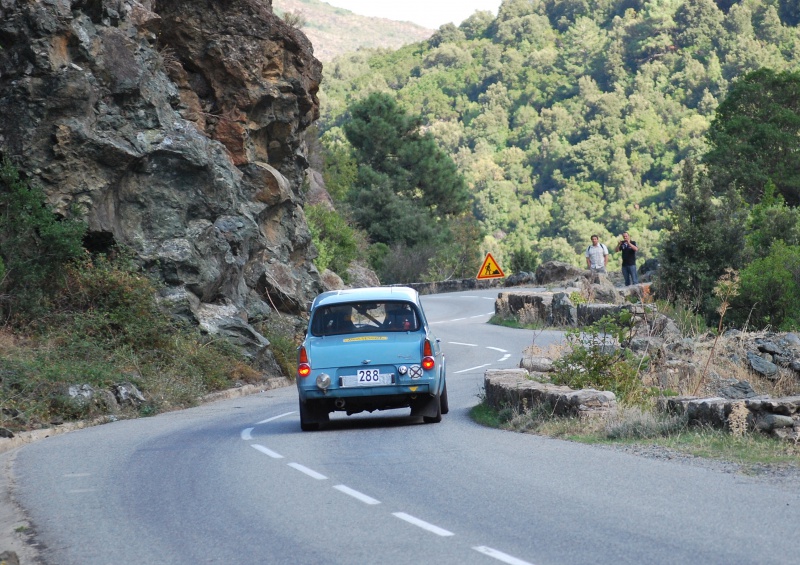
[7,291,800,565]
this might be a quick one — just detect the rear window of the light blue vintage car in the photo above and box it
[311,301,420,336]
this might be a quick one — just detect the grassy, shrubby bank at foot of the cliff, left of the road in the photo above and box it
[0,255,272,432]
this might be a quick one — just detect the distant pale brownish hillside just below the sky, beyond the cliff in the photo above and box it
[272,0,433,62]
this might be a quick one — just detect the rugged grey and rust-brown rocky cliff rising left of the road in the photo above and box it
[0,0,322,362]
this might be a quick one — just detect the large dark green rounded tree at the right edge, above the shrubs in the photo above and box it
[705,69,800,206]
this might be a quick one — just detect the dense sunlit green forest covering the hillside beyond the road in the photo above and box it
[310,0,800,302]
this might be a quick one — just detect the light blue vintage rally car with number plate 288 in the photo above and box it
[297,286,448,431]
